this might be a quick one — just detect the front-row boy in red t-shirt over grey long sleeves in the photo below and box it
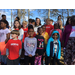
[6,30,22,65]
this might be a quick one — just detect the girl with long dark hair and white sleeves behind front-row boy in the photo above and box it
[11,20,24,41]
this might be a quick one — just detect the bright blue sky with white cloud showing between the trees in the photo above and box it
[0,9,74,26]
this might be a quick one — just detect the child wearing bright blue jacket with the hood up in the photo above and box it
[46,31,61,65]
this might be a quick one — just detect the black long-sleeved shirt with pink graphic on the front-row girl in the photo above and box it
[35,35,46,55]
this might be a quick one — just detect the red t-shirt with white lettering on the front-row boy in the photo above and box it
[6,39,22,60]
